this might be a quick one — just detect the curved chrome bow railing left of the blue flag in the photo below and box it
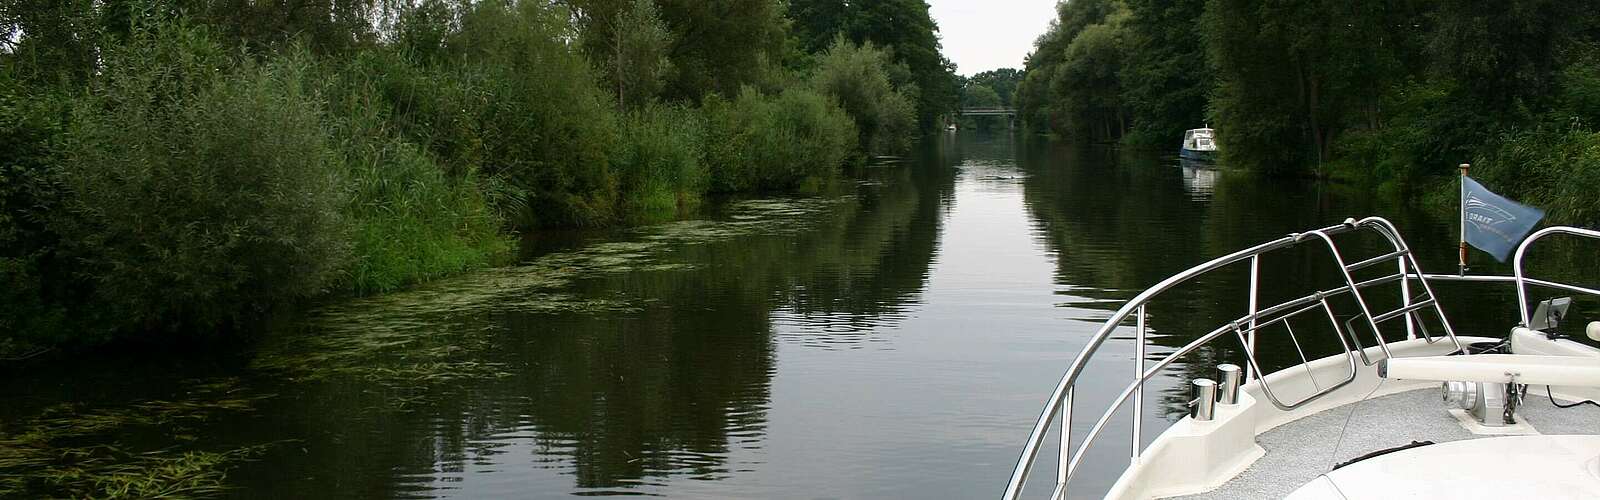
[1003,218,1462,500]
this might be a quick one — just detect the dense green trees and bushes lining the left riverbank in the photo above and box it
[0,0,957,357]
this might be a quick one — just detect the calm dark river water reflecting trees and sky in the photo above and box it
[0,133,1574,498]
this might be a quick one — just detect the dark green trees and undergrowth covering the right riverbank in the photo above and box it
[1016,0,1600,226]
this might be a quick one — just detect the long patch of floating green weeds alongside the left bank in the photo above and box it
[253,199,848,389]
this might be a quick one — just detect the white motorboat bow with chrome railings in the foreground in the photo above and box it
[1003,218,1600,500]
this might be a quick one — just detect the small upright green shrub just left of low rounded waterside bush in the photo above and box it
[611,106,707,220]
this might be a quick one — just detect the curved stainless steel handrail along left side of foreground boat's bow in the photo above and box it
[1003,218,1461,500]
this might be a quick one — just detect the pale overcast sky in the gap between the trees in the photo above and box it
[928,0,1056,77]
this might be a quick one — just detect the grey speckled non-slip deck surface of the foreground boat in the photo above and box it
[1174,386,1600,498]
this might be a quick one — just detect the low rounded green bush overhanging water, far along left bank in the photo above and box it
[704,88,856,191]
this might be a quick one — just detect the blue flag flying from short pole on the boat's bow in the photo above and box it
[1461,176,1544,263]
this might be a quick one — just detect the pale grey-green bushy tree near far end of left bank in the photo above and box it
[811,37,917,154]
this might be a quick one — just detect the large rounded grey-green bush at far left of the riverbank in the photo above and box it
[53,26,349,336]
